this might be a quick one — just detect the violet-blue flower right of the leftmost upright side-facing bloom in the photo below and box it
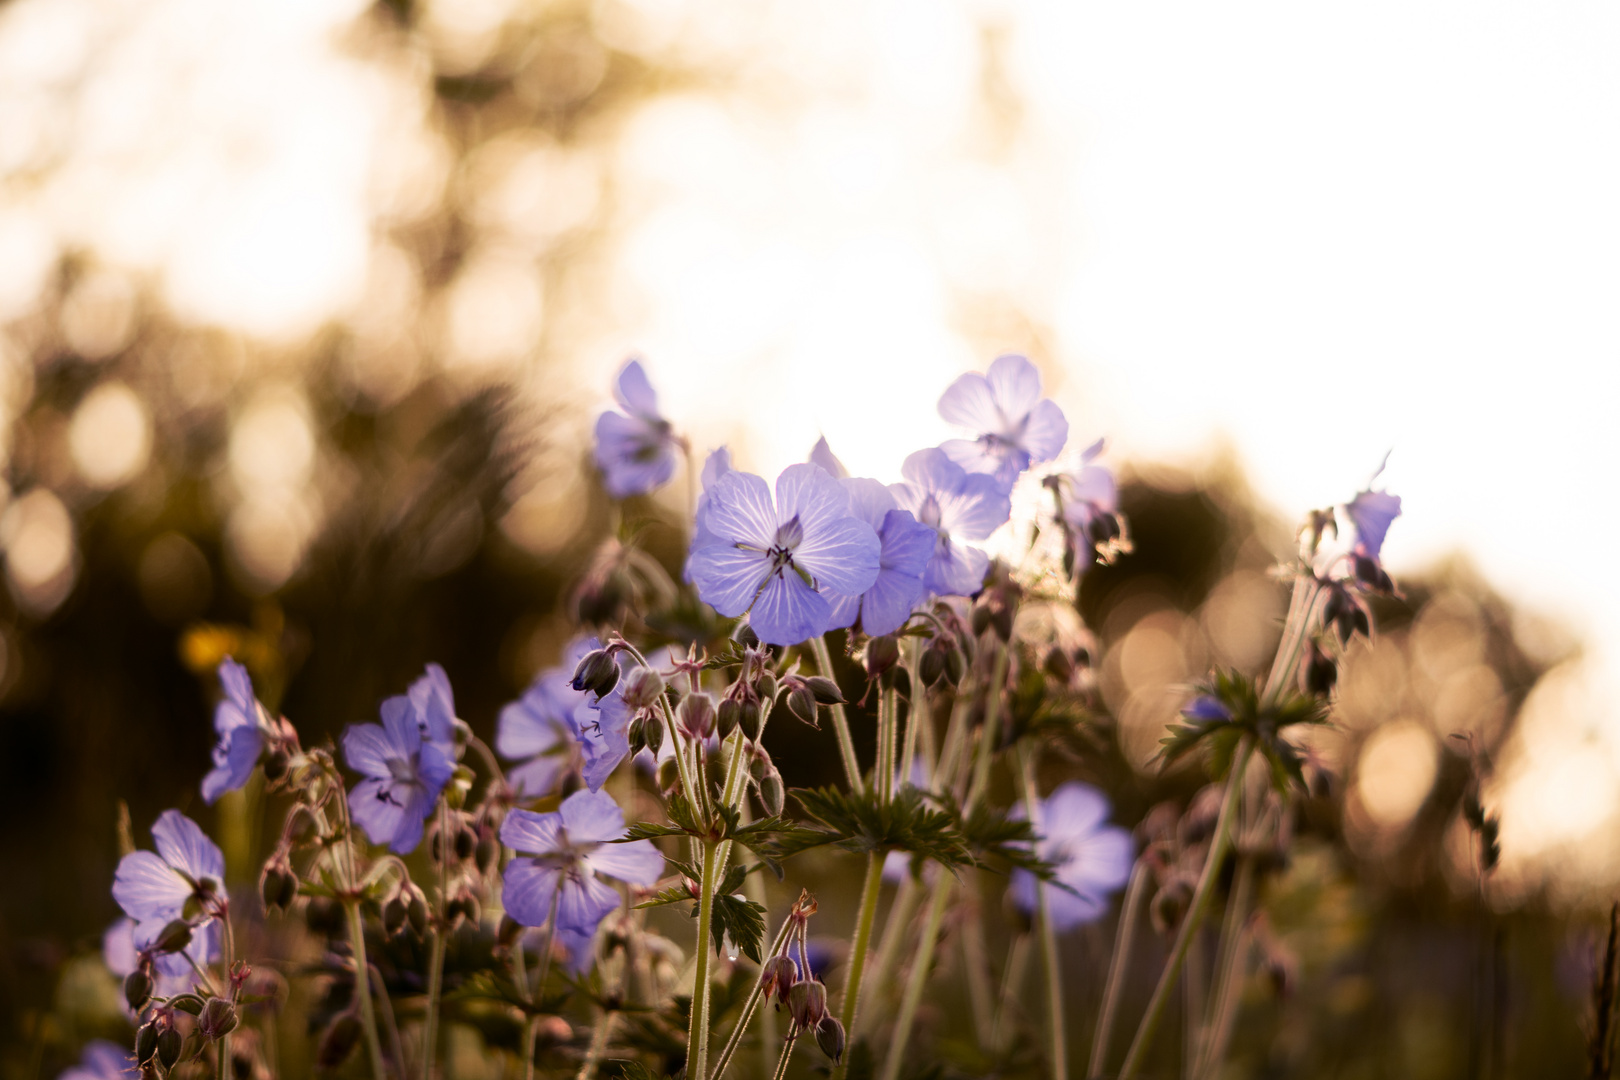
[343,695,455,855]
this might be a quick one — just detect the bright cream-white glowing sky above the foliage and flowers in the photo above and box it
[0,0,1620,887]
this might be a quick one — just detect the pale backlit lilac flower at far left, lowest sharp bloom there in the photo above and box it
[112,810,225,941]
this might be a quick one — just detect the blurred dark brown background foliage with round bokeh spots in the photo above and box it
[0,0,1596,1077]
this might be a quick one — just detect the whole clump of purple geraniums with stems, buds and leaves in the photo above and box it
[63,356,1412,1080]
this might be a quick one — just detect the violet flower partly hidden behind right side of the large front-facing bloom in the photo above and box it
[816,476,936,636]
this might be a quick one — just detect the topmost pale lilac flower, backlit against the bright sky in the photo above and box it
[940,355,1069,491]
